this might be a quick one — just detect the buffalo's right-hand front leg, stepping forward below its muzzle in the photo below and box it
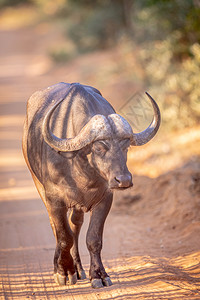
[86,194,113,288]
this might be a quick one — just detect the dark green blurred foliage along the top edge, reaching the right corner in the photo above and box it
[51,0,200,60]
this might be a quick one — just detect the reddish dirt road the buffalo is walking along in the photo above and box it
[0,22,200,300]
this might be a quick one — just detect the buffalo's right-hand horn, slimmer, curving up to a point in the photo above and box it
[131,92,161,146]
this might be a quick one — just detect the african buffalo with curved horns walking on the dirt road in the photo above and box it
[23,82,160,288]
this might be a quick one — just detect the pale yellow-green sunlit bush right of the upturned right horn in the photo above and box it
[140,37,200,129]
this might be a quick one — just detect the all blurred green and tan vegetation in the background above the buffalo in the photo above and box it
[0,0,200,130]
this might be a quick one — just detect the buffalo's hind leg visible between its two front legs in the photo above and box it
[68,208,86,279]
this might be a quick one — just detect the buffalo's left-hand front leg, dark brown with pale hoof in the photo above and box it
[49,204,77,285]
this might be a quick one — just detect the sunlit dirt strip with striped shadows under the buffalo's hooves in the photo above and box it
[0,252,200,299]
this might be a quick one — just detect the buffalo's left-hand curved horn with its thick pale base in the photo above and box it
[42,99,111,152]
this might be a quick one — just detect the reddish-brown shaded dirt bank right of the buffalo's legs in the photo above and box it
[113,157,200,257]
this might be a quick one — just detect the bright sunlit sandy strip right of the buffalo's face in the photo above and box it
[128,126,200,177]
